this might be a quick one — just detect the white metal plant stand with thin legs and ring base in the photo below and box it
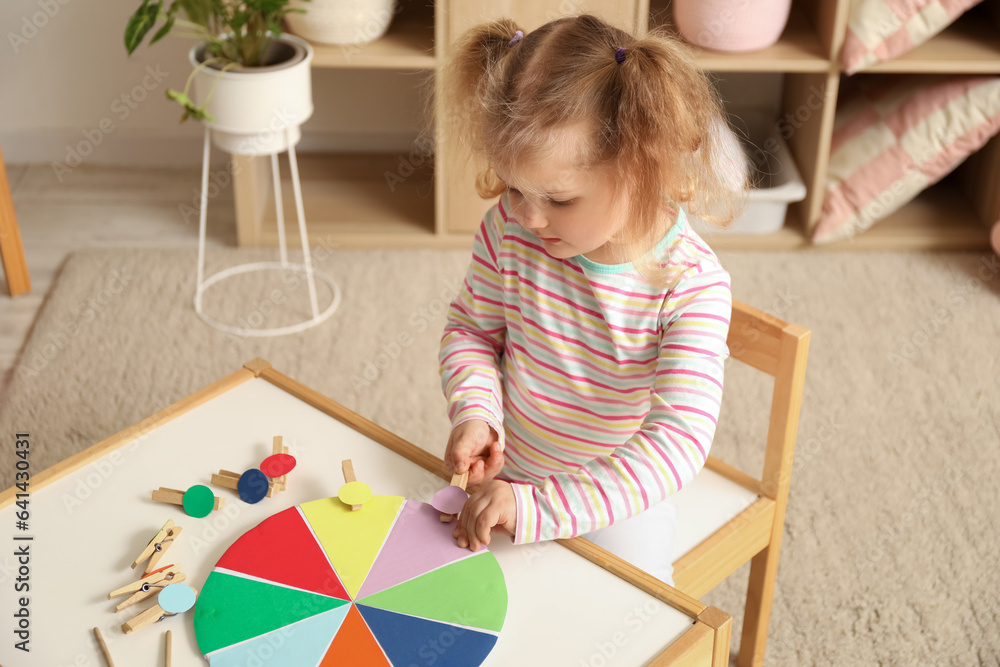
[194,125,340,338]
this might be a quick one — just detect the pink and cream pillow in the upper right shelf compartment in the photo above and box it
[840,0,982,74]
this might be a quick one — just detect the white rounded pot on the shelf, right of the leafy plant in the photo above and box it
[285,0,396,44]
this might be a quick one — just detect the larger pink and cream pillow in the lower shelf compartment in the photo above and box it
[812,74,1000,243]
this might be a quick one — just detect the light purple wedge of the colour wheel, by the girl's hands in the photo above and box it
[355,500,473,600]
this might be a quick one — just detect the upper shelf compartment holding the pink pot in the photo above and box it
[649,0,830,72]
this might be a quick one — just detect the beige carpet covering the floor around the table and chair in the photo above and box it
[0,250,1000,665]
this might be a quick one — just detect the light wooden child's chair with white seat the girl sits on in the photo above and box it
[672,302,809,667]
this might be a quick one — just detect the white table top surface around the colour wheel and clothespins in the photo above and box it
[0,378,692,667]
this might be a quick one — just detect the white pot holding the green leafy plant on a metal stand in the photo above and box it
[189,34,313,155]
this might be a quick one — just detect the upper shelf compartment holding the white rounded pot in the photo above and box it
[298,2,436,69]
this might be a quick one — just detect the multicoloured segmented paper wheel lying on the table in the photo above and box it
[194,496,507,667]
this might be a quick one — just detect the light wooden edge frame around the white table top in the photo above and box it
[0,358,732,667]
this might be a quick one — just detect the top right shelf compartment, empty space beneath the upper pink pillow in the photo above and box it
[861,4,1000,74]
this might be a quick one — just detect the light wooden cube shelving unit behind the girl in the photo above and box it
[234,0,1000,250]
